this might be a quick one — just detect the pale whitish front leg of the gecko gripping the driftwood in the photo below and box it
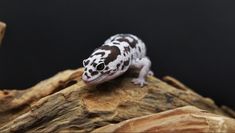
[131,57,153,87]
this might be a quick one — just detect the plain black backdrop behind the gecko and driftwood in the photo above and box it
[0,0,235,109]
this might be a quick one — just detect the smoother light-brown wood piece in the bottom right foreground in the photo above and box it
[93,106,235,133]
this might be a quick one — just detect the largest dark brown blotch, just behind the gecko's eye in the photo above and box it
[100,45,121,65]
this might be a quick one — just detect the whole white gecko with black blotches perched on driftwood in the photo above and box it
[82,34,153,87]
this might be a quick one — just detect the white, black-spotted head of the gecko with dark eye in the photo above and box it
[82,57,115,85]
